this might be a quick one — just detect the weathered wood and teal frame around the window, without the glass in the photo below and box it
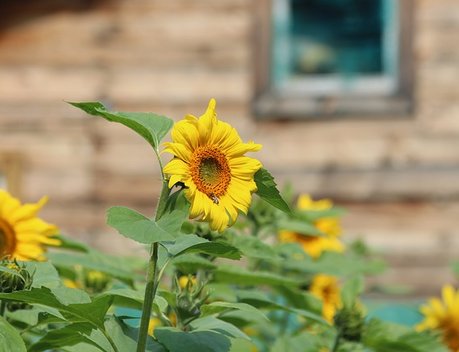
[253,0,413,119]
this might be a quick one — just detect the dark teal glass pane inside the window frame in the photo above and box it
[289,0,383,75]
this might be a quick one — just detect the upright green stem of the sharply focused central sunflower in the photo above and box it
[137,180,170,352]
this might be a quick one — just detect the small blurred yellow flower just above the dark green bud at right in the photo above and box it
[309,274,341,323]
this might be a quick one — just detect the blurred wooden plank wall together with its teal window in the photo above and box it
[0,0,459,296]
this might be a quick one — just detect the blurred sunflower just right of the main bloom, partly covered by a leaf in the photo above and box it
[279,194,344,259]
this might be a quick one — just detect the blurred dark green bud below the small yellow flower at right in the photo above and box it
[334,304,364,341]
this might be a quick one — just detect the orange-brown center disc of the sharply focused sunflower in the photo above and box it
[190,146,231,204]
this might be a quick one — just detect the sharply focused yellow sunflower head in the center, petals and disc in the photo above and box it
[164,99,262,232]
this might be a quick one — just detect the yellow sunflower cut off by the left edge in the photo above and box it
[0,190,61,260]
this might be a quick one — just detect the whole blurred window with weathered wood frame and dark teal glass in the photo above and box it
[255,0,412,118]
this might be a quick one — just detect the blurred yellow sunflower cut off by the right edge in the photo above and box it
[416,285,459,352]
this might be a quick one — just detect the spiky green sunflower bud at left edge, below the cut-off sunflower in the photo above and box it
[0,259,32,293]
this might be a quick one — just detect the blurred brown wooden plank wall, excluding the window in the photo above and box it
[0,0,459,294]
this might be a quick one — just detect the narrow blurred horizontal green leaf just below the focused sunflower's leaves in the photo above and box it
[214,265,298,286]
